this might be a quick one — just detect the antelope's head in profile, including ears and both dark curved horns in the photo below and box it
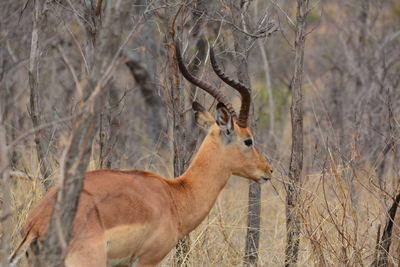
[176,41,272,184]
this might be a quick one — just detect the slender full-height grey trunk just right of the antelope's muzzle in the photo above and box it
[285,0,308,266]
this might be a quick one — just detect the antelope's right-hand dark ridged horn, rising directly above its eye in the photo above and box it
[210,47,251,128]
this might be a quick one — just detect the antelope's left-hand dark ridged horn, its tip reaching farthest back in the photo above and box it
[175,39,236,120]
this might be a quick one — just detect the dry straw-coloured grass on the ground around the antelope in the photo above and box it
[3,147,400,266]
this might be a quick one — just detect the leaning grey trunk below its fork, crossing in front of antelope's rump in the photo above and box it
[44,98,100,266]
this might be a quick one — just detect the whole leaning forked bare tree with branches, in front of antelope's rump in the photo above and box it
[33,1,139,266]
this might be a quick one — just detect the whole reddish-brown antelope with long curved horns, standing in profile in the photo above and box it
[11,41,272,267]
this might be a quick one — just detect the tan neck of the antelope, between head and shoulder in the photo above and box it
[172,135,232,239]
